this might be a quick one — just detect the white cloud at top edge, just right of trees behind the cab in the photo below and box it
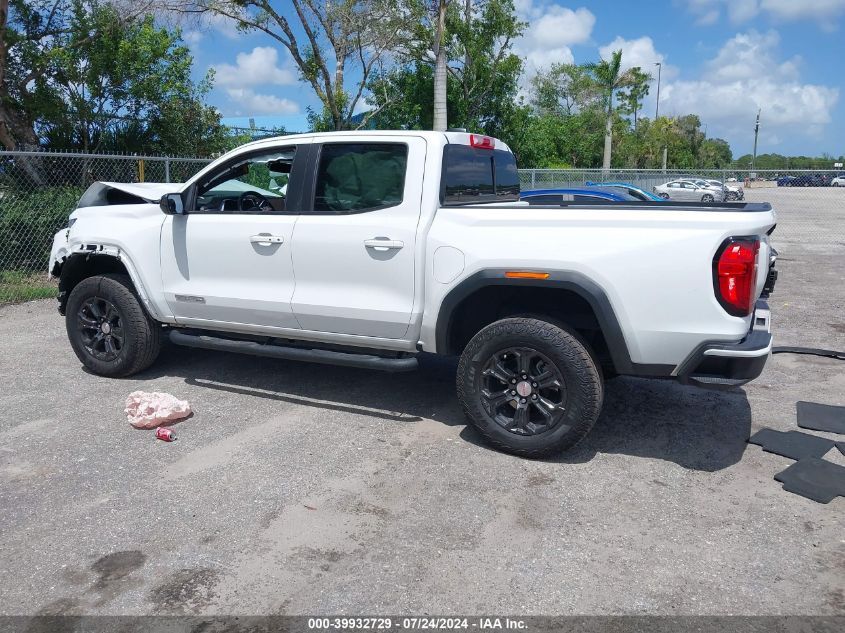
[514,0,596,75]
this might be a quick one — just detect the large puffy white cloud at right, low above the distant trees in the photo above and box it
[660,31,839,144]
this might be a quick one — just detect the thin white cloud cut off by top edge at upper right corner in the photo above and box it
[687,0,845,29]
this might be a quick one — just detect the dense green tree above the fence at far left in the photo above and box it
[0,0,228,155]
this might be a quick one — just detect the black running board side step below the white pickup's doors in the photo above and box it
[170,330,417,372]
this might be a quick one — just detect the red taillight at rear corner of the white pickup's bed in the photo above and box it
[713,238,760,316]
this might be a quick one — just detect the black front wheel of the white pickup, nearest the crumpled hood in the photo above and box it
[65,274,161,378]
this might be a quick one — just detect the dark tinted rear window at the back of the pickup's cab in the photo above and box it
[440,143,519,206]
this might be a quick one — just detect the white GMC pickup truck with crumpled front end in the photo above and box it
[50,131,776,456]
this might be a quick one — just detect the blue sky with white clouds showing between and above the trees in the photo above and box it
[183,0,845,156]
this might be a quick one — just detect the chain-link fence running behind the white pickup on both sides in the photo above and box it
[0,152,845,312]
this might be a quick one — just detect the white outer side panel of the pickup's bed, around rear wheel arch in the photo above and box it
[421,203,774,364]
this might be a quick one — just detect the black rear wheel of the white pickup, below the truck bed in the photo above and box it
[457,318,604,458]
